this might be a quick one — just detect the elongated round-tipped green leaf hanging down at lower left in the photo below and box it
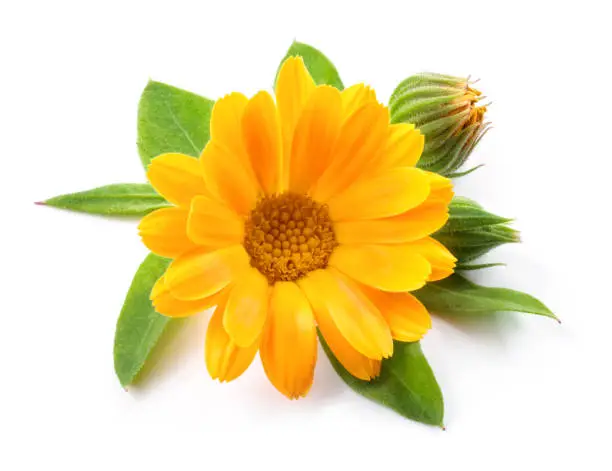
[114,254,171,387]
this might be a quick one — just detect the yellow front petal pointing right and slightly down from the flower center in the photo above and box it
[329,244,431,293]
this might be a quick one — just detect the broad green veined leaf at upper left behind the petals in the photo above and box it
[138,81,214,168]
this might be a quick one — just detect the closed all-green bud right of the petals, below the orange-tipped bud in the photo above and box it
[433,197,520,269]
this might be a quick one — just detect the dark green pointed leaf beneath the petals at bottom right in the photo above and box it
[319,335,444,427]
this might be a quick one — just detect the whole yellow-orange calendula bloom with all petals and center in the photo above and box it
[139,57,455,398]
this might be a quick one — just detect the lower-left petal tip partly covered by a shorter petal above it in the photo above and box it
[205,300,259,382]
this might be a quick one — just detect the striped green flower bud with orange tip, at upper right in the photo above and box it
[389,73,490,176]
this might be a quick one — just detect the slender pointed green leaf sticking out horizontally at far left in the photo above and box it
[37,183,169,216]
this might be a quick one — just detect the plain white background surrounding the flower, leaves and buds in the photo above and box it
[0,0,612,471]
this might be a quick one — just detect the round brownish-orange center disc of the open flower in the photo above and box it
[244,193,338,284]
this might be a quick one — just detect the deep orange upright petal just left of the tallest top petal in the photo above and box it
[242,92,282,194]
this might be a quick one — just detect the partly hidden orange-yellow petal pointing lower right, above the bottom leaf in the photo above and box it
[361,285,431,342]
